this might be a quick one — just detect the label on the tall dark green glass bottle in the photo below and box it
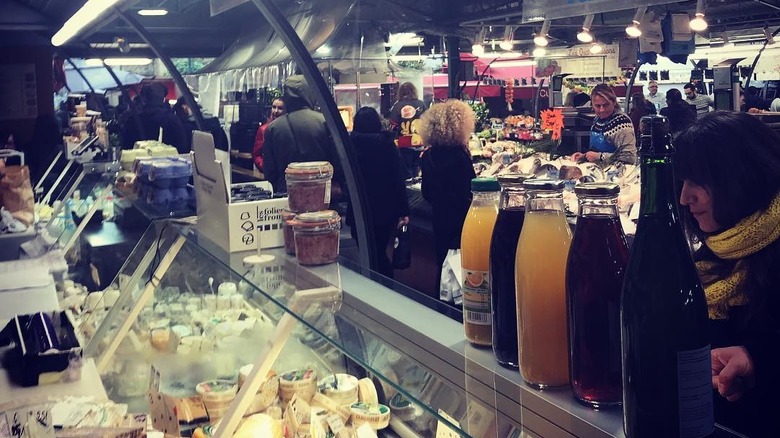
[677,345,715,438]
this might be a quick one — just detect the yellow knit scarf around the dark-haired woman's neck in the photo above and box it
[696,194,780,319]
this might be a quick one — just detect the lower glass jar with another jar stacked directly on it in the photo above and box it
[292,210,341,266]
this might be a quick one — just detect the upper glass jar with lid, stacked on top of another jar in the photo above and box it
[284,161,333,213]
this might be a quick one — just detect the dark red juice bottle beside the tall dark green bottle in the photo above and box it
[566,183,628,407]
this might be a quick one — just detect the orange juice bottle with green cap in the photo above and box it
[460,178,500,345]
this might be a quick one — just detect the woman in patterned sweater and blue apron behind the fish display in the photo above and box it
[571,84,636,166]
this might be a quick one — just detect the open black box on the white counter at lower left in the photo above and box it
[0,312,82,386]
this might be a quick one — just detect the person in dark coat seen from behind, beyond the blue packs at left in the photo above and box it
[121,83,189,153]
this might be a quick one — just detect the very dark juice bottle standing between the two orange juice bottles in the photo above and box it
[490,173,533,369]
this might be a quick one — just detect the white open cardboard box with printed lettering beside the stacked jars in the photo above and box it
[191,131,287,252]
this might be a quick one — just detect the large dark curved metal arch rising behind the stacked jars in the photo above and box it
[245,0,377,275]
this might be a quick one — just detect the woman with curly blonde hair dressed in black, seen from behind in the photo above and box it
[420,100,476,283]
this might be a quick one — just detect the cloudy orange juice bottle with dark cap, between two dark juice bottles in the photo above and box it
[515,179,571,389]
